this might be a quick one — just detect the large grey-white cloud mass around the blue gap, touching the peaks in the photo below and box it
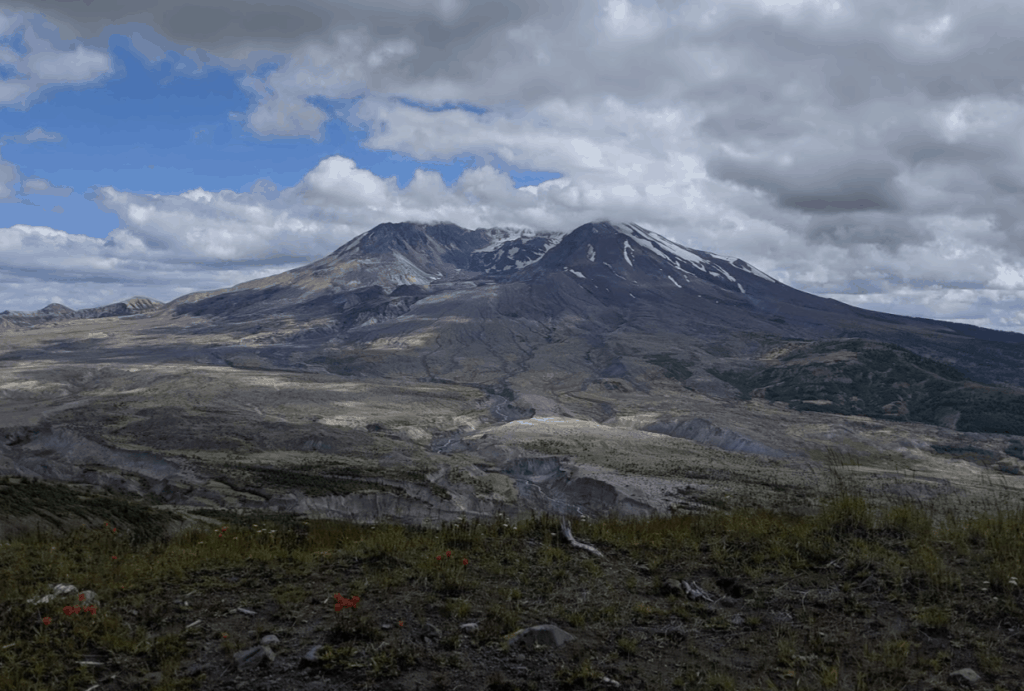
[0,0,1024,331]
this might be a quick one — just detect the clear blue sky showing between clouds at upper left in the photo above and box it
[0,32,559,243]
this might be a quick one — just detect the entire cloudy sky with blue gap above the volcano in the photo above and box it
[0,0,1024,333]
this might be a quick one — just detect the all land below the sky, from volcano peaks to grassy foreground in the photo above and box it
[0,220,1024,689]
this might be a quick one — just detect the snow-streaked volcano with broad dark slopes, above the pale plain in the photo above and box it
[6,221,1024,434]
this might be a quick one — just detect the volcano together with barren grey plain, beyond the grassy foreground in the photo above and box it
[0,221,1024,527]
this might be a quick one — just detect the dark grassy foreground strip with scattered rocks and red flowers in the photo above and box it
[0,458,1024,691]
